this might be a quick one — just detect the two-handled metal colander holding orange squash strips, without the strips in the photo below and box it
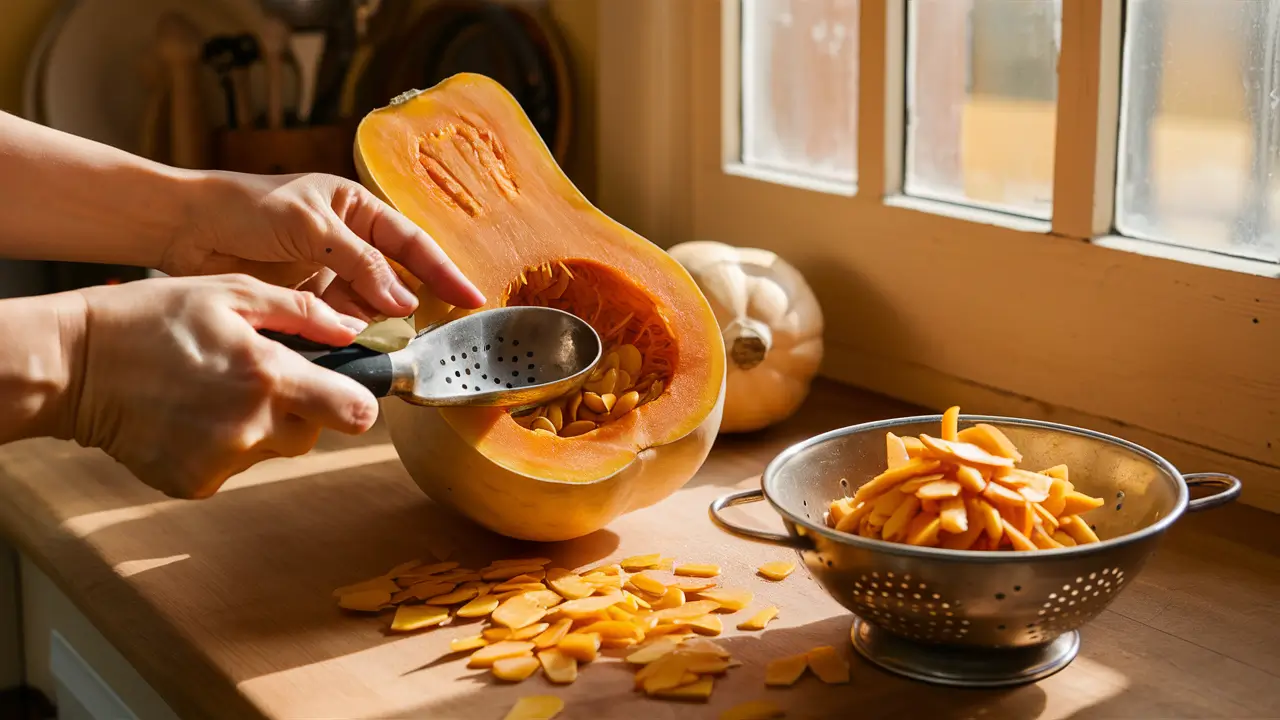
[710,415,1240,687]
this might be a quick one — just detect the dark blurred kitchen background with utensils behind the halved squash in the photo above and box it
[0,0,602,297]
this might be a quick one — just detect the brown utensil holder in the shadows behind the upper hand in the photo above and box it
[214,122,357,179]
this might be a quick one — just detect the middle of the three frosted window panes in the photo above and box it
[904,0,1061,219]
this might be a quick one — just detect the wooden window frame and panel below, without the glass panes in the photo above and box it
[598,0,1280,511]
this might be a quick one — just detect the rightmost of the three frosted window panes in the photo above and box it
[1116,0,1280,261]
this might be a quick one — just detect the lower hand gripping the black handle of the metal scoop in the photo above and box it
[70,275,378,498]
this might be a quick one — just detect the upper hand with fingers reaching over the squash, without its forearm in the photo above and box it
[159,172,484,320]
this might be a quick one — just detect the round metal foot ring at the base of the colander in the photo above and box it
[850,618,1080,688]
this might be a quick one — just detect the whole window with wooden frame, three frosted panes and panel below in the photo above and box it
[600,0,1280,510]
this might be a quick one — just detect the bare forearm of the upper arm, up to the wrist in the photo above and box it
[0,113,200,268]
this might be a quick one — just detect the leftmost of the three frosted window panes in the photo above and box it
[742,0,858,184]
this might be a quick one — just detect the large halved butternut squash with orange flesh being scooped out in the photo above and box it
[356,73,724,541]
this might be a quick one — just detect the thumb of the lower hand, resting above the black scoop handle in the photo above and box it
[222,277,367,347]
